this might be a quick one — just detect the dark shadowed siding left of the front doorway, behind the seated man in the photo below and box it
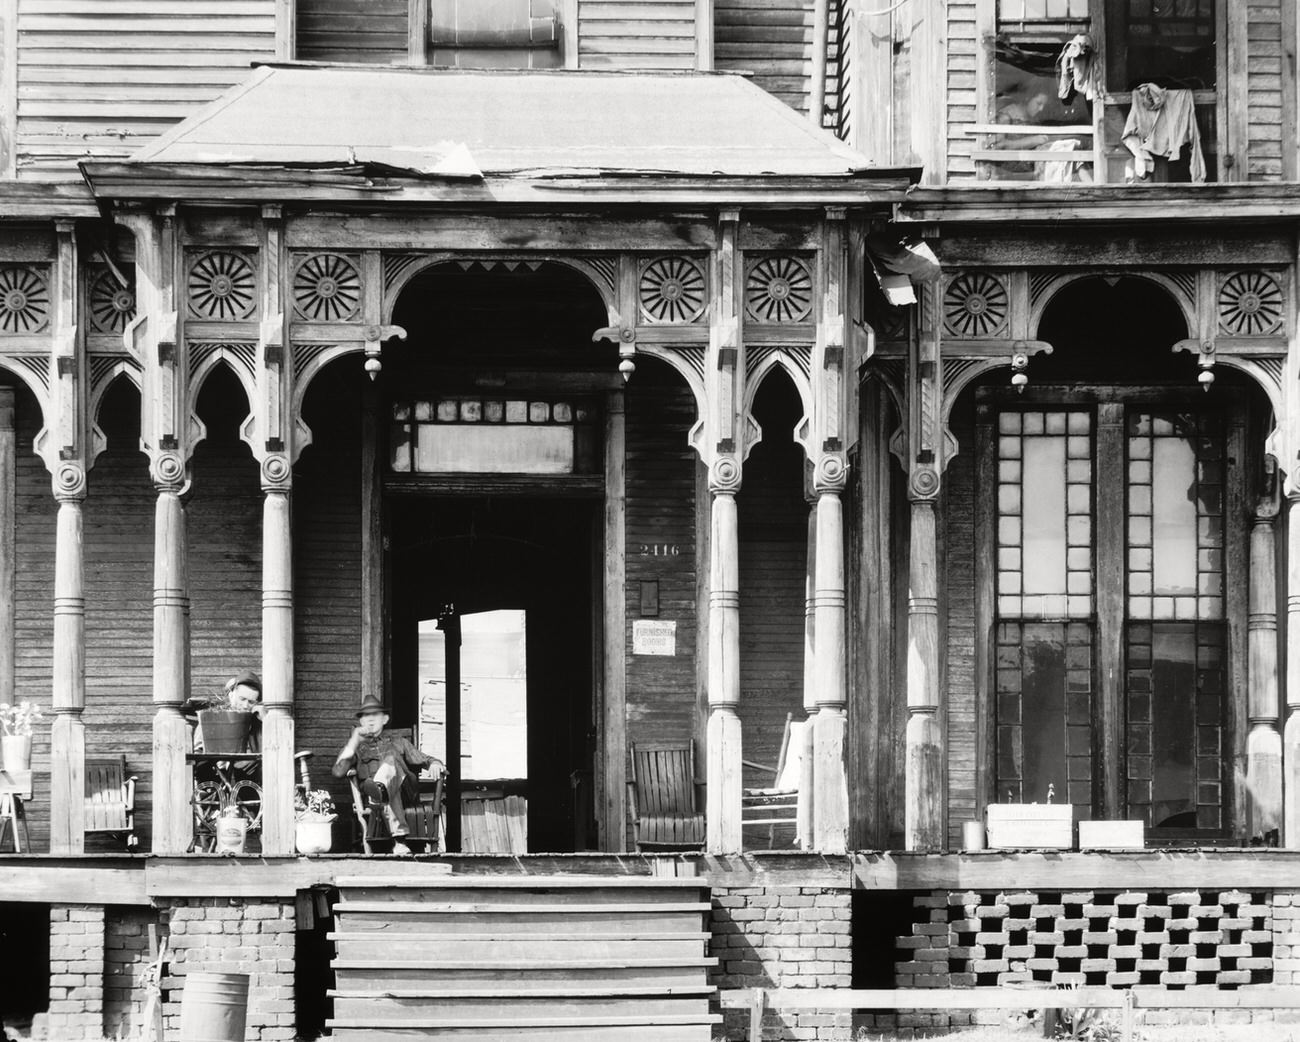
[294,356,361,850]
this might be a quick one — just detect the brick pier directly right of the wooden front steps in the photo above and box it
[711,886,853,1042]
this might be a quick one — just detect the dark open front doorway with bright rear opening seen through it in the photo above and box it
[389,495,599,852]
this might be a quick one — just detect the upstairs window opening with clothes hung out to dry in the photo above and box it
[975,0,1225,182]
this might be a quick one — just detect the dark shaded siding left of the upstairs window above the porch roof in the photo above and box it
[295,0,410,65]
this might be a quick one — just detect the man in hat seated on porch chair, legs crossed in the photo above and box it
[334,695,442,854]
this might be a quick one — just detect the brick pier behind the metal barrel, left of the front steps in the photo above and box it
[164,898,295,1042]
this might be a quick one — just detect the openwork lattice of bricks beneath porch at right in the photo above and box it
[896,890,1273,989]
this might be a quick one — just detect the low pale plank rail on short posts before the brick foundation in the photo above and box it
[719,985,1300,1042]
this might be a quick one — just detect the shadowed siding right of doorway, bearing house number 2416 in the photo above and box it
[625,360,703,748]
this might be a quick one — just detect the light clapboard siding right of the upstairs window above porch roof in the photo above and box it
[577,0,696,69]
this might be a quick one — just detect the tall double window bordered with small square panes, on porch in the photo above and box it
[982,395,1240,837]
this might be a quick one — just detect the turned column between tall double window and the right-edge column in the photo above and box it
[1245,496,1282,838]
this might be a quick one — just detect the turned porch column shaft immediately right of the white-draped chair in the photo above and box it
[813,487,849,854]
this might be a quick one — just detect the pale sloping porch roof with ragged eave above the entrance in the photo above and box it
[83,64,917,201]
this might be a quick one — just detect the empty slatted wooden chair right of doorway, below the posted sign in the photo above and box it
[628,742,705,851]
